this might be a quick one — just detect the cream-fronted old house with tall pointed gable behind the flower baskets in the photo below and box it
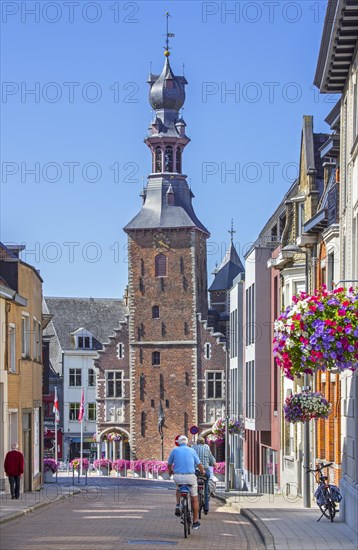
[267,116,328,494]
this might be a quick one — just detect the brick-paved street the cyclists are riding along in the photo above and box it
[1,479,264,550]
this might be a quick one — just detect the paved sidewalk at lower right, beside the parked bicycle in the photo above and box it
[226,495,358,550]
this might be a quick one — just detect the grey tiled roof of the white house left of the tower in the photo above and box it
[45,297,127,350]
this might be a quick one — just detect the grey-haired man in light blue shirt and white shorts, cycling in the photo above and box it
[168,435,205,529]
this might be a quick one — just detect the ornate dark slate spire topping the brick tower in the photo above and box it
[125,16,209,236]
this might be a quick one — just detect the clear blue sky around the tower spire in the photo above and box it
[1,0,336,297]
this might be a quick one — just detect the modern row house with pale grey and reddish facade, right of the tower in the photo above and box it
[242,182,297,490]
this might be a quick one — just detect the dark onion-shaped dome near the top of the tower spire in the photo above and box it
[149,58,185,111]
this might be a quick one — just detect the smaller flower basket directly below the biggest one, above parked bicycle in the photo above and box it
[283,392,332,424]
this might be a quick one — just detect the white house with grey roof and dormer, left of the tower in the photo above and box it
[44,297,126,461]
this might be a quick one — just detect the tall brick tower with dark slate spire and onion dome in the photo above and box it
[124,48,209,459]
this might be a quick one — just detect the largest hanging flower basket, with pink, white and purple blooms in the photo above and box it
[273,287,358,380]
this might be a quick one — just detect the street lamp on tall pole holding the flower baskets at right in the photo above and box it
[282,244,311,508]
